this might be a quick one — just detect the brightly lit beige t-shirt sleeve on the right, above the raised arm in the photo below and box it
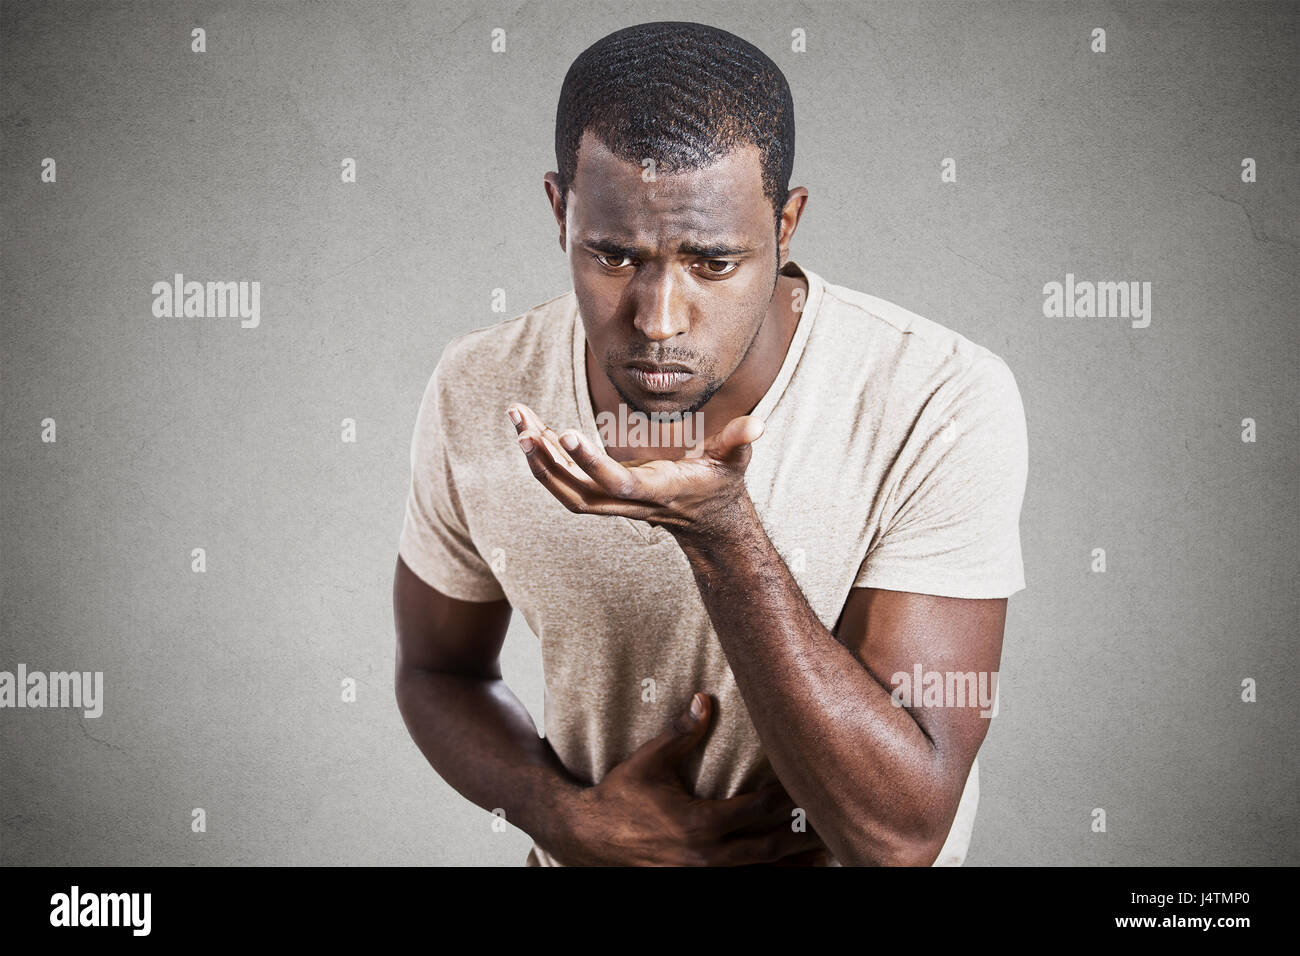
[854,352,1028,598]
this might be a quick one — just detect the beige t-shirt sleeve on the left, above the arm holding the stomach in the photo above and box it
[398,354,506,601]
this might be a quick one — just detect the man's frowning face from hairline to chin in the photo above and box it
[551,134,779,415]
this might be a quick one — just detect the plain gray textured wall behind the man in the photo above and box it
[0,1,1300,865]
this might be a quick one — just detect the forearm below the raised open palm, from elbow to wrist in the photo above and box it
[675,497,943,864]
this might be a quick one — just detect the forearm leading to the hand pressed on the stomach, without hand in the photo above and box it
[397,665,584,848]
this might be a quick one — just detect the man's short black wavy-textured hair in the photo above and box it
[555,20,794,234]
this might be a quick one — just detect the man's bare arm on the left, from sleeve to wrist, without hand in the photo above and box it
[393,557,581,847]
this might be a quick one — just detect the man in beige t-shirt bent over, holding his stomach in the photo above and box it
[394,22,1027,865]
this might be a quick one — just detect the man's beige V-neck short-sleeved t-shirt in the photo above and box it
[399,261,1028,866]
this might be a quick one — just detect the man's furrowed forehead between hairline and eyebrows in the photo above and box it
[569,133,771,242]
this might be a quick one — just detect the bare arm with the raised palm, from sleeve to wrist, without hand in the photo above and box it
[670,497,1006,865]
